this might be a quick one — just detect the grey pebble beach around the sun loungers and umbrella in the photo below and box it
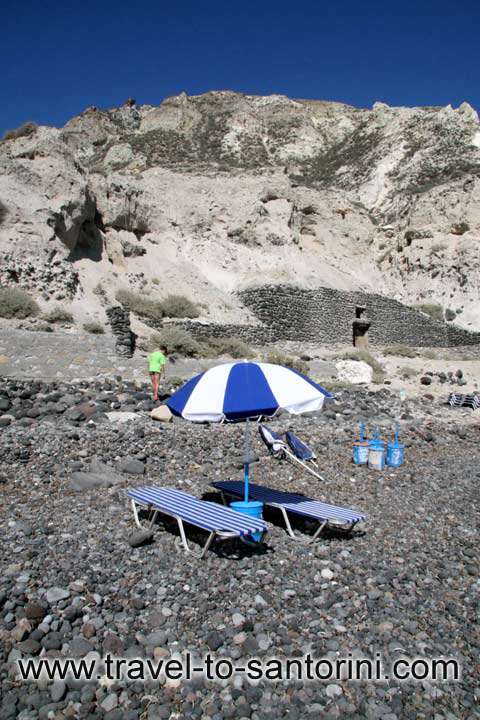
[0,378,480,720]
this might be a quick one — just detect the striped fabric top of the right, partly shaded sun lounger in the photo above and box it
[212,480,366,523]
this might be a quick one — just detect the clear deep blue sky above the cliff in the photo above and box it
[0,0,480,132]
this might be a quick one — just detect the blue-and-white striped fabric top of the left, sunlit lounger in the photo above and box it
[128,487,267,537]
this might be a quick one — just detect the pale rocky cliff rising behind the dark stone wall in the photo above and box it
[0,92,480,330]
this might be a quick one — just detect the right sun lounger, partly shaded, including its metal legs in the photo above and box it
[212,480,366,542]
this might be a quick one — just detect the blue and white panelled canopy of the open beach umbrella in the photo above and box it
[166,361,333,422]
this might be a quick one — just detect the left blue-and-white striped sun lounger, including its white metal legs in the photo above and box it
[127,487,267,558]
